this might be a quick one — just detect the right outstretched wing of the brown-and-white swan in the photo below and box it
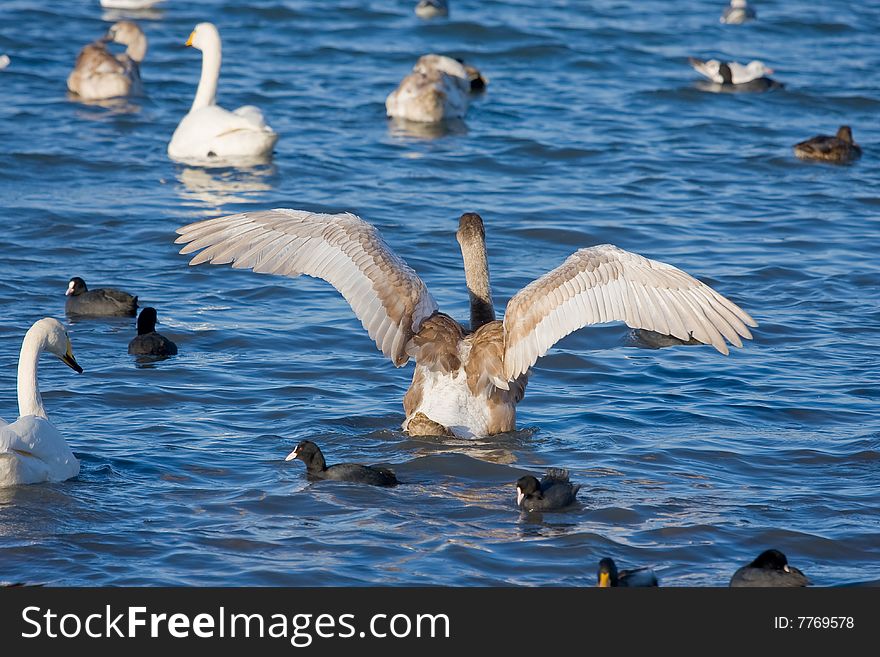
[504,244,757,381]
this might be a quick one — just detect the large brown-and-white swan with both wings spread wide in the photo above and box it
[176,208,757,438]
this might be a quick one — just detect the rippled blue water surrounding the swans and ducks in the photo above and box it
[0,0,880,586]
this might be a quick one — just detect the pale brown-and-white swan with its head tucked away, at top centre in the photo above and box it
[385,54,487,123]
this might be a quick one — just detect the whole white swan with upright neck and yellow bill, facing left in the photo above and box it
[168,23,278,163]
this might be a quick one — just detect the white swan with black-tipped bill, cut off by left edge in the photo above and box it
[0,317,82,487]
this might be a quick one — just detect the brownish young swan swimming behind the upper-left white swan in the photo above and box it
[67,21,147,100]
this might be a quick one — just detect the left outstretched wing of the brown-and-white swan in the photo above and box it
[176,209,437,367]
